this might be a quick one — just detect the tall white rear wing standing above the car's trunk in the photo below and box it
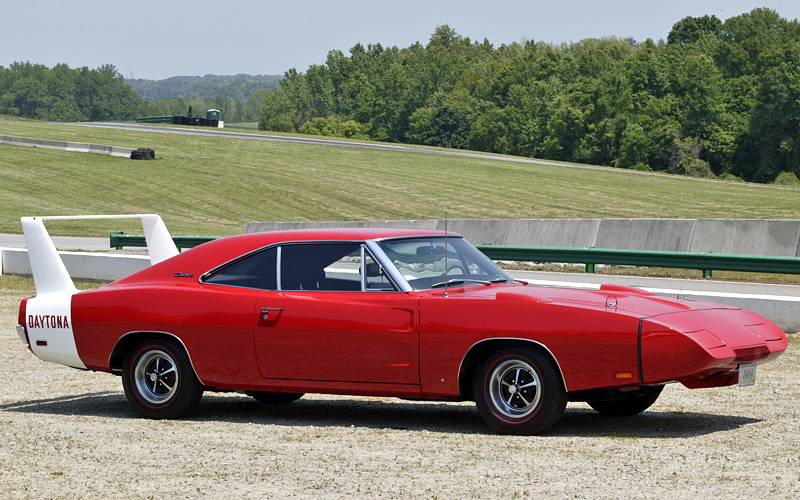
[22,214,178,295]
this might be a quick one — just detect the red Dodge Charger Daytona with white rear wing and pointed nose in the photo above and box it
[17,215,787,434]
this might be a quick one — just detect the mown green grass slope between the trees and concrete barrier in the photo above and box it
[0,120,800,236]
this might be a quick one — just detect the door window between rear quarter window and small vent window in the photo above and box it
[281,243,361,291]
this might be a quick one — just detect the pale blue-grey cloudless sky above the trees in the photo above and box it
[0,0,800,79]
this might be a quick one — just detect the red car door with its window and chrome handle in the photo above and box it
[254,242,419,384]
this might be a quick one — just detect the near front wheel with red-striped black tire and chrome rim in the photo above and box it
[473,347,567,436]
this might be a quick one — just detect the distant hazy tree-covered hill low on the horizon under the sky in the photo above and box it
[125,74,283,101]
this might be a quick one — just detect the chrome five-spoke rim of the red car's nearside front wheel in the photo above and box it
[488,359,541,419]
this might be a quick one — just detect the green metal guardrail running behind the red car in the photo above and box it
[109,232,800,278]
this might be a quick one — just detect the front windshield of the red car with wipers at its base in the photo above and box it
[378,236,514,290]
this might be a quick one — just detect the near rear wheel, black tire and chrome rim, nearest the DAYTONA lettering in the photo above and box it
[122,340,203,419]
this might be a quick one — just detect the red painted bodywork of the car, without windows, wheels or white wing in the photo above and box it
[37,229,787,398]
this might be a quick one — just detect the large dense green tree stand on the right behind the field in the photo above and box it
[259,8,800,182]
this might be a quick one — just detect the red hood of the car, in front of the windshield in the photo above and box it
[465,285,739,317]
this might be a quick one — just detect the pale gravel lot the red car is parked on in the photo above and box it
[0,277,800,499]
